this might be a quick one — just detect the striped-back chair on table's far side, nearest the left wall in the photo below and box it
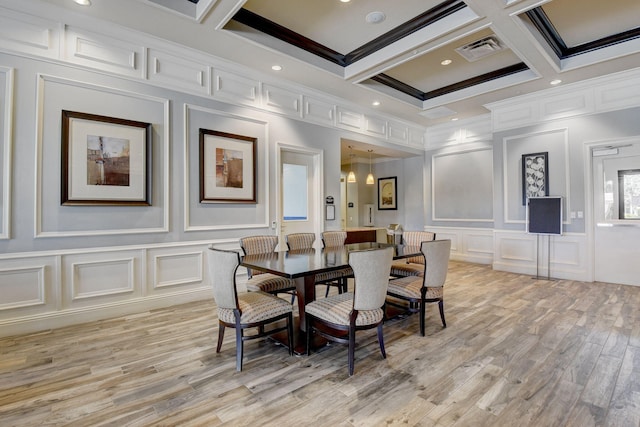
[240,235,296,304]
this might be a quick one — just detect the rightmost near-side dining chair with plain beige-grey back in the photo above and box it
[387,240,451,336]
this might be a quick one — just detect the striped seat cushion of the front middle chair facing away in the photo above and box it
[305,292,384,326]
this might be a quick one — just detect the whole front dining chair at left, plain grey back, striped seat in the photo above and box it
[207,247,293,371]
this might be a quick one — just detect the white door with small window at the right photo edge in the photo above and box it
[592,143,640,286]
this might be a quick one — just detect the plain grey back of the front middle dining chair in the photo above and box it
[349,247,393,310]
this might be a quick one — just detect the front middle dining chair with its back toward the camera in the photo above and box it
[305,247,393,376]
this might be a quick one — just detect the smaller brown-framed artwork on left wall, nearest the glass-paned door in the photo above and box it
[200,129,257,203]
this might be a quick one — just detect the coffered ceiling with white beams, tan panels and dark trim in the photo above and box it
[35,0,640,132]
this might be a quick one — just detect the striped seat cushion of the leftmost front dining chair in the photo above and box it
[218,292,291,323]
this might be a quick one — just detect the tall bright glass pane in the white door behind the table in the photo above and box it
[282,163,309,221]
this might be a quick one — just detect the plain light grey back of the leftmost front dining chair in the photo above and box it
[207,248,240,309]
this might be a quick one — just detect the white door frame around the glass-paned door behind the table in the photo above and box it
[275,142,324,250]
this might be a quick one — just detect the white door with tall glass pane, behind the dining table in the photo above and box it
[280,149,321,250]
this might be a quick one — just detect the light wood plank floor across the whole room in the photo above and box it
[0,262,640,427]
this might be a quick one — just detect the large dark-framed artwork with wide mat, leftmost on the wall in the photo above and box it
[61,110,153,206]
